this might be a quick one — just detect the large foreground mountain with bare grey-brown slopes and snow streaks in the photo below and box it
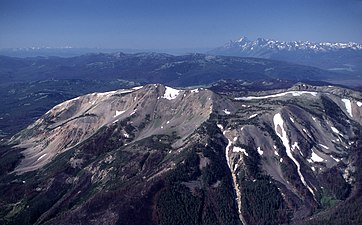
[0,81,362,224]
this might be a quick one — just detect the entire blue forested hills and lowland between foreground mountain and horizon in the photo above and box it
[0,53,350,139]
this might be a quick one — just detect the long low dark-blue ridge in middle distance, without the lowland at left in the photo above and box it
[0,53,346,86]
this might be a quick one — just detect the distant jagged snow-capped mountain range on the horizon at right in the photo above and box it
[209,37,362,78]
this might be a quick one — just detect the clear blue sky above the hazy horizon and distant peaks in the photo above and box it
[0,0,362,49]
